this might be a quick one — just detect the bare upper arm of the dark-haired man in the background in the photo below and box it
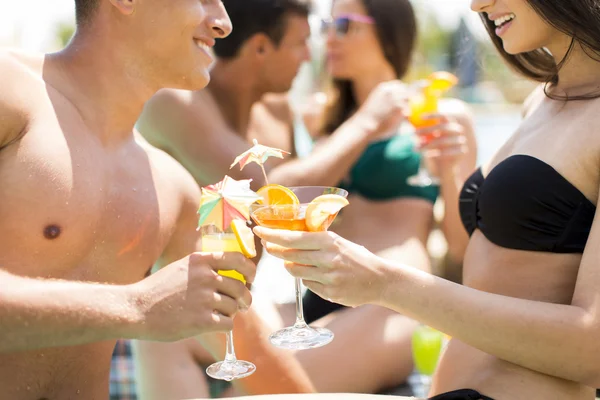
[137,89,264,188]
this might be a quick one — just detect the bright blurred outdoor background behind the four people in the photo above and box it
[0,0,533,162]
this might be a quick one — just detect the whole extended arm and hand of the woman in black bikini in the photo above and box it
[255,222,600,387]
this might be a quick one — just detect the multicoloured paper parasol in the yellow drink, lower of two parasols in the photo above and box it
[198,176,261,231]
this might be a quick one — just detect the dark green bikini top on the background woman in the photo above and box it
[341,135,440,203]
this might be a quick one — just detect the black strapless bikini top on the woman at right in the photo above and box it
[459,154,596,253]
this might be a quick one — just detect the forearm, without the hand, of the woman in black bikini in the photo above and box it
[377,258,600,387]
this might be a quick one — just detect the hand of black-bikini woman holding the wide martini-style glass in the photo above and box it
[254,227,386,307]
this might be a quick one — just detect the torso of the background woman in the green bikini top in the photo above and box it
[333,132,439,270]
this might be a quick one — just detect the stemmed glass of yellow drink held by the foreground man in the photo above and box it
[200,225,256,381]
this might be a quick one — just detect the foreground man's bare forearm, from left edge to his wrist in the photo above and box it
[0,268,141,353]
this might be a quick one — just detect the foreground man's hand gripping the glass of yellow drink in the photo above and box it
[134,252,256,341]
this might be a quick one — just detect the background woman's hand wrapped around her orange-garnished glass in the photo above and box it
[416,113,469,175]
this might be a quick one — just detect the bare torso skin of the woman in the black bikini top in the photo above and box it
[432,94,600,400]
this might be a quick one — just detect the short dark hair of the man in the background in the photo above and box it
[214,0,310,58]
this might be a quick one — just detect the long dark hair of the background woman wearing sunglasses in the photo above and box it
[323,0,417,133]
